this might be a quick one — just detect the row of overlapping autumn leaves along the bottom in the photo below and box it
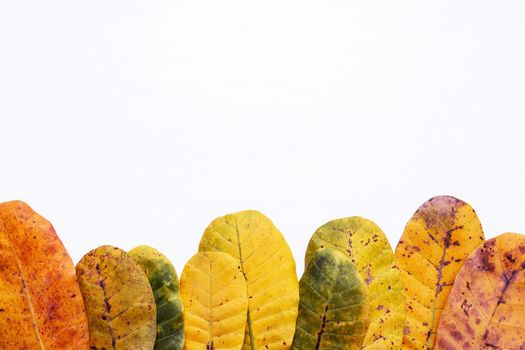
[0,196,525,350]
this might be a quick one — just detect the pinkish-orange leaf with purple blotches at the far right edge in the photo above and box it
[436,233,525,350]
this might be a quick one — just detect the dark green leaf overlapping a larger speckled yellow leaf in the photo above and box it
[292,248,370,350]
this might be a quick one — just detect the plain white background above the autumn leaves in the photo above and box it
[0,0,525,273]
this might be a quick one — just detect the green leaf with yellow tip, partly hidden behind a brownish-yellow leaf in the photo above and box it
[128,245,184,350]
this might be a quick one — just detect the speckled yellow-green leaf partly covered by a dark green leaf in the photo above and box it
[305,216,405,349]
